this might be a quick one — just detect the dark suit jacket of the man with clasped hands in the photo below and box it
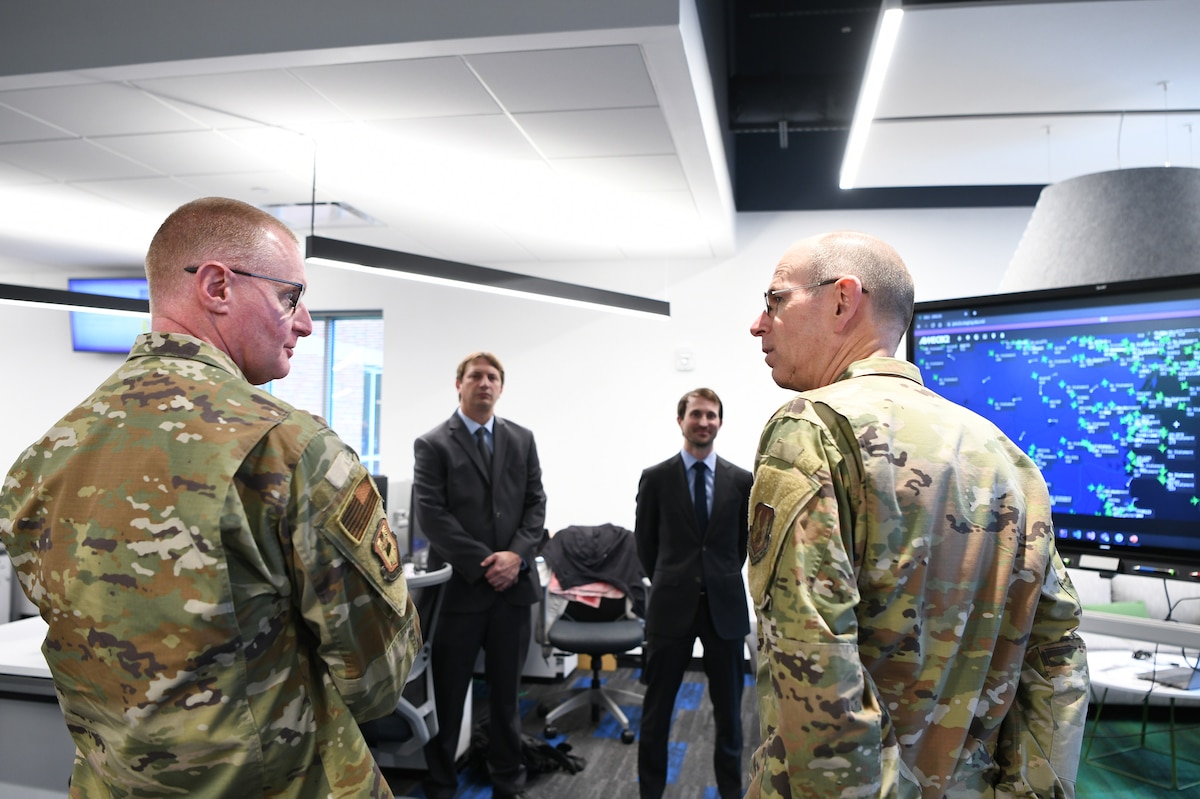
[413,413,546,613]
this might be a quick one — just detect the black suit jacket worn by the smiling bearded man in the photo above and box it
[634,455,754,639]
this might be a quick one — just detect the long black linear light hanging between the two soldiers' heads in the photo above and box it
[305,236,671,317]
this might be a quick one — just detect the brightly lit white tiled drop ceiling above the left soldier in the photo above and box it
[0,0,733,277]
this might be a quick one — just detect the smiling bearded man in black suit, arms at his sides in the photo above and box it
[634,389,754,799]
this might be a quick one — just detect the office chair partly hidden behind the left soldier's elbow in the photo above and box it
[359,565,451,769]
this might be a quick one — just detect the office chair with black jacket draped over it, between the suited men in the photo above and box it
[538,525,649,744]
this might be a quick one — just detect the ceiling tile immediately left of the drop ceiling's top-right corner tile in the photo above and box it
[293,58,500,120]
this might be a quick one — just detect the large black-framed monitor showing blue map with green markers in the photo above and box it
[907,275,1200,581]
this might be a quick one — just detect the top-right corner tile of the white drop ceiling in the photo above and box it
[467,44,658,114]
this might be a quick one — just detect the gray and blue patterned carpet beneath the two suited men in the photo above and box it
[384,663,758,799]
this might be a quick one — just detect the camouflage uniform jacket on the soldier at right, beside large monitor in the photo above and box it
[746,358,1087,799]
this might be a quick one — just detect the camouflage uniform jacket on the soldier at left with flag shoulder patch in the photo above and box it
[0,334,420,799]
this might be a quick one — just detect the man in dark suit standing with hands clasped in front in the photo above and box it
[413,353,546,799]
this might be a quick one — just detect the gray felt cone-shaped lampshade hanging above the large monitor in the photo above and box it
[1001,167,1200,292]
